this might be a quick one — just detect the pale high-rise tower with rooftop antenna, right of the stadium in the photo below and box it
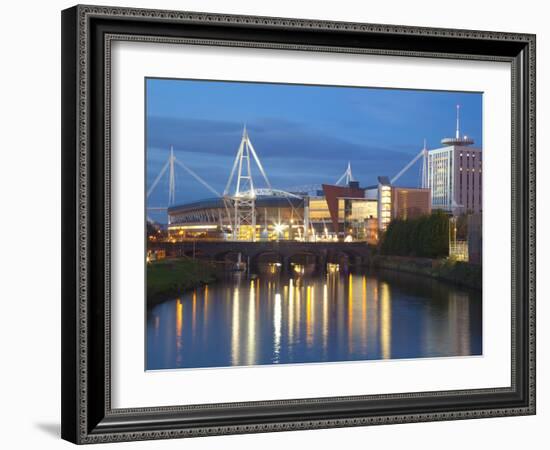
[426,105,482,214]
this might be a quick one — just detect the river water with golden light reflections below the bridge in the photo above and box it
[147,266,482,369]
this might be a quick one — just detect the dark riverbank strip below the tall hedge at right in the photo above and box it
[372,255,482,290]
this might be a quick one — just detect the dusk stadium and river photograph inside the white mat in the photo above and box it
[146,77,484,371]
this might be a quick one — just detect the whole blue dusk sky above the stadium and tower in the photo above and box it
[146,79,482,221]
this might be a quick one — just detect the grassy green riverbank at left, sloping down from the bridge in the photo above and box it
[147,258,224,307]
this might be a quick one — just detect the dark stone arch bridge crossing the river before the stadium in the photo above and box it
[149,240,373,268]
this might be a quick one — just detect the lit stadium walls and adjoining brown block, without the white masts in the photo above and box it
[168,177,431,244]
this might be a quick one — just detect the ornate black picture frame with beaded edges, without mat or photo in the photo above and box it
[62,6,535,444]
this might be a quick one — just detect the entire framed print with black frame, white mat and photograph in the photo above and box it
[62,6,535,443]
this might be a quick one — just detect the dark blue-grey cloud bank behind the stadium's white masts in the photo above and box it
[147,117,426,202]
